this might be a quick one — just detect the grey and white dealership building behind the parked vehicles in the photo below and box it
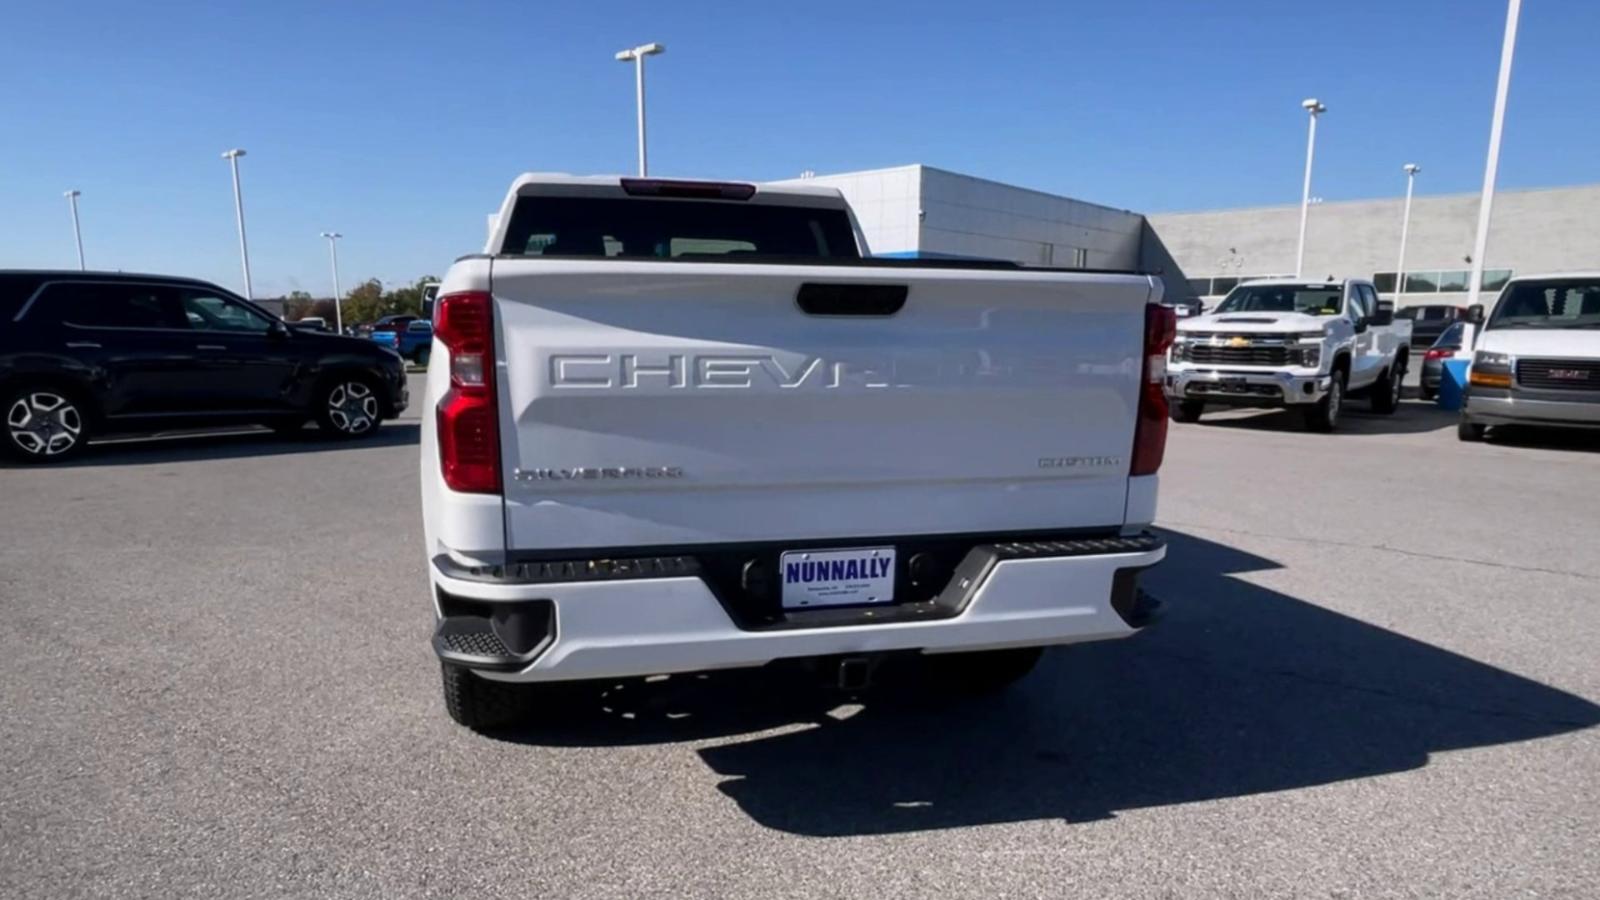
[802,165,1600,306]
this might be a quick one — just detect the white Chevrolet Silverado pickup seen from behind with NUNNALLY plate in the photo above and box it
[421,175,1173,729]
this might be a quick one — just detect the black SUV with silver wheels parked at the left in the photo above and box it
[0,271,406,461]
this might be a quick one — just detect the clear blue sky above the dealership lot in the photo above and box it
[0,0,1600,295]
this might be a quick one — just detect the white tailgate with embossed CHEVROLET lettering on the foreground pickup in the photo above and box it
[491,258,1152,551]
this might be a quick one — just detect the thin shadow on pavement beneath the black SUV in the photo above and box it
[0,420,421,469]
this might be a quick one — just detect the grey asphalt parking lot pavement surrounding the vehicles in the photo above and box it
[0,371,1600,897]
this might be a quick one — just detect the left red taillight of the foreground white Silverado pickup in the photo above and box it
[434,291,501,493]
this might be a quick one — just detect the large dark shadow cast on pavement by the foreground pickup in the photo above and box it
[506,533,1600,836]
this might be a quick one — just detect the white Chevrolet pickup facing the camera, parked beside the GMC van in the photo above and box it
[1166,279,1411,431]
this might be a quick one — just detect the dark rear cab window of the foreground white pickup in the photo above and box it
[501,197,859,259]
